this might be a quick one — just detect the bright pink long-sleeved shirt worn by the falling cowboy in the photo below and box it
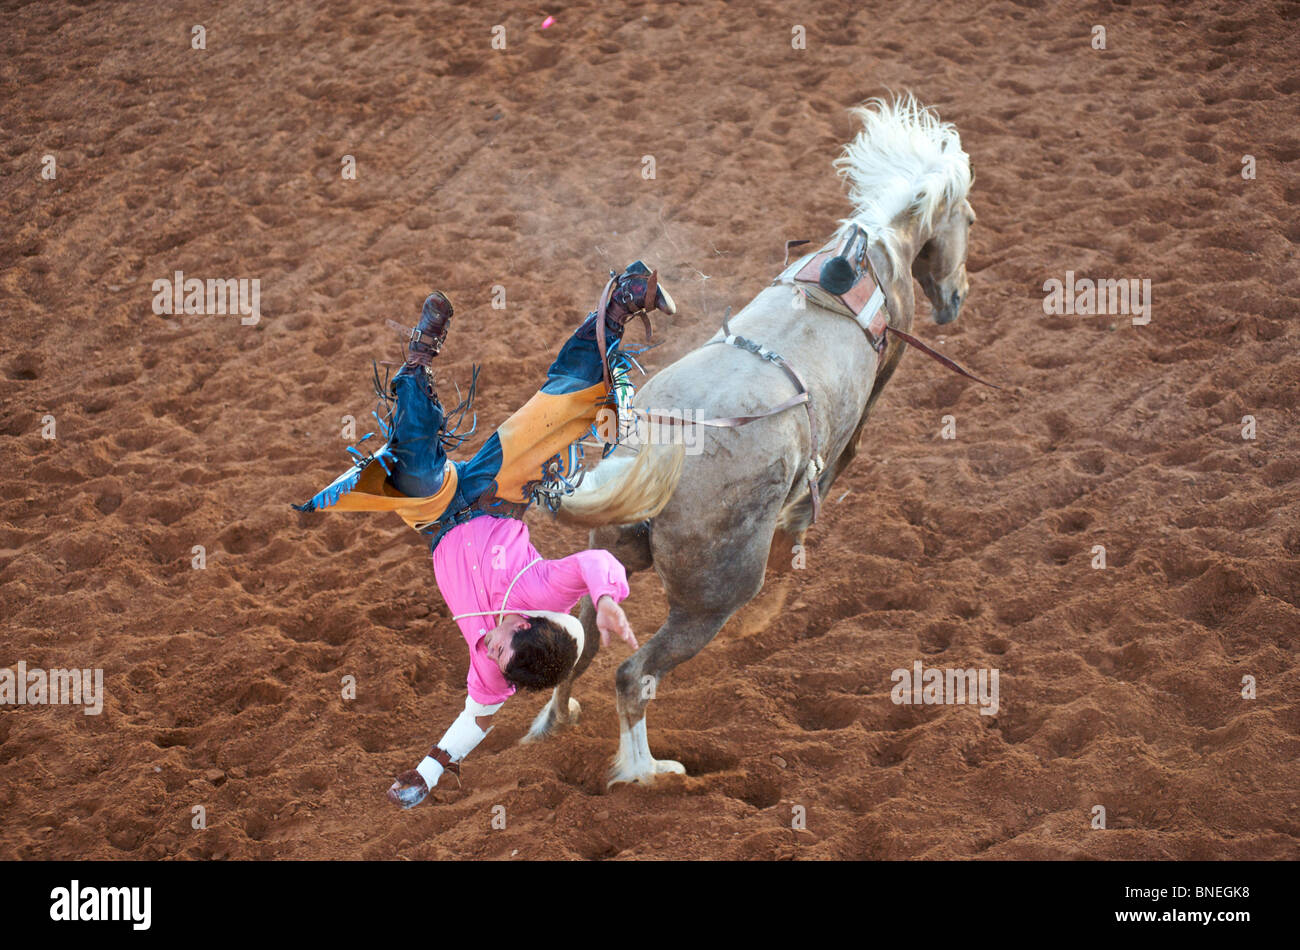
[433,515,628,706]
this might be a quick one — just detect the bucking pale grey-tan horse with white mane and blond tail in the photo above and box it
[525,95,975,785]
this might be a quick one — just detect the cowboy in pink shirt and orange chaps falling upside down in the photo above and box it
[294,261,676,808]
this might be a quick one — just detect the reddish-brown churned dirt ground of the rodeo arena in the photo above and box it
[0,0,1300,859]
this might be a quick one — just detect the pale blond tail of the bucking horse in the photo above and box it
[555,443,686,528]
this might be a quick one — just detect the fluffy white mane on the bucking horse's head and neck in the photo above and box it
[833,92,971,263]
